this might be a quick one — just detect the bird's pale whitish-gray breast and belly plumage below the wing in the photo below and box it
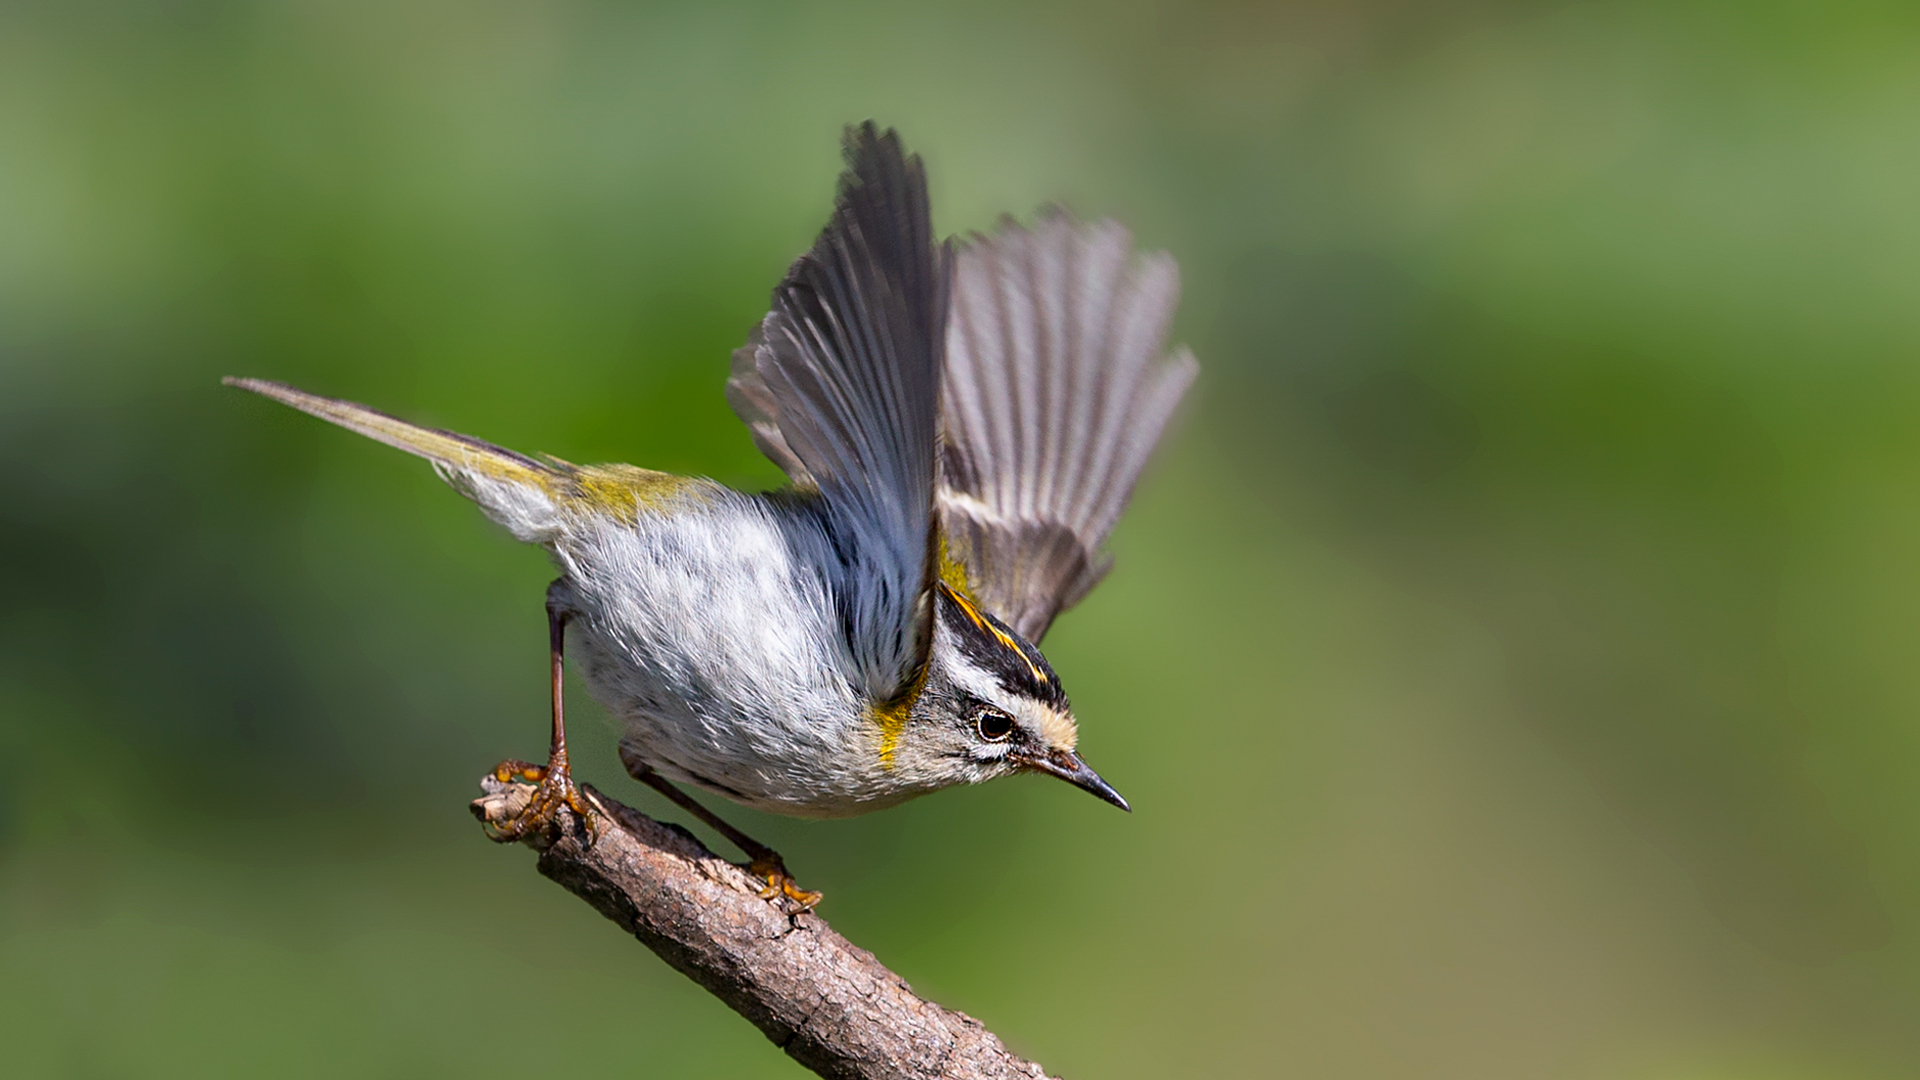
[555,484,872,815]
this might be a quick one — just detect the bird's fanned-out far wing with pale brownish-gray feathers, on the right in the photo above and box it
[937,209,1198,642]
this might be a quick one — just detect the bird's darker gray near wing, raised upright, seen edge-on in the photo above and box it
[728,121,947,700]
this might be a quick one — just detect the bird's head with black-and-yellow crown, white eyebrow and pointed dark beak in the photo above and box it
[881,582,1133,809]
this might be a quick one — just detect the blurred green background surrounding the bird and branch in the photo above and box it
[0,0,1920,1080]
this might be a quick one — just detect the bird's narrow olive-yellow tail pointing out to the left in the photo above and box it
[221,379,570,544]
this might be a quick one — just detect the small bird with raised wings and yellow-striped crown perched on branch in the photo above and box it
[227,121,1198,907]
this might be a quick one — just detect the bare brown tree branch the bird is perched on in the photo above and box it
[472,776,1046,1080]
